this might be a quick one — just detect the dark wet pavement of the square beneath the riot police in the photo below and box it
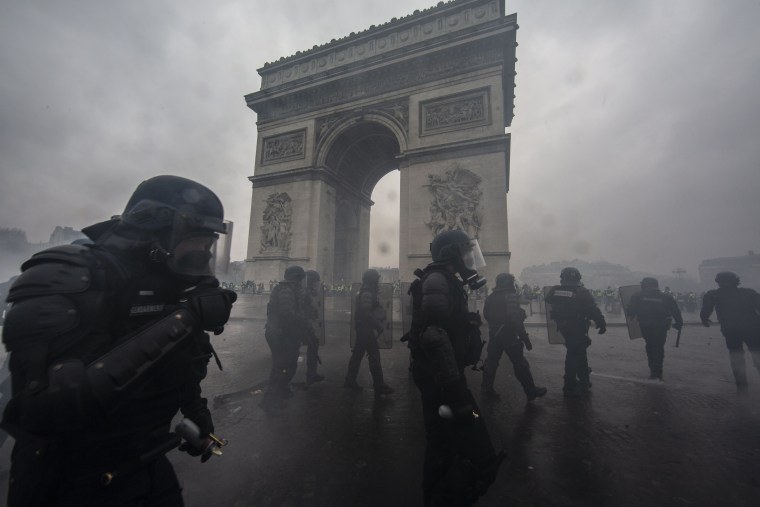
[0,295,760,507]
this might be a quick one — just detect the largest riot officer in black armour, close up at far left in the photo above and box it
[3,176,236,507]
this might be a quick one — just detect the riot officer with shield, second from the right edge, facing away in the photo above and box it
[628,277,683,380]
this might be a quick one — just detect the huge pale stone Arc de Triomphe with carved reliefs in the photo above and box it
[246,0,518,282]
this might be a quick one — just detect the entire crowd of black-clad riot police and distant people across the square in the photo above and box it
[1,176,760,507]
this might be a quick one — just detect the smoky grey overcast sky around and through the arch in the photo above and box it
[0,0,760,276]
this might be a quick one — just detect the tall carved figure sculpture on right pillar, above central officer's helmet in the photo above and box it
[425,164,483,238]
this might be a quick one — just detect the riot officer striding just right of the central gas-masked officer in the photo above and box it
[481,273,546,401]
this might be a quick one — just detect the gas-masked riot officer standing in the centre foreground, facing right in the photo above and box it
[409,231,504,506]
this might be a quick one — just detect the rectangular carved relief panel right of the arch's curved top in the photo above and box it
[420,88,491,136]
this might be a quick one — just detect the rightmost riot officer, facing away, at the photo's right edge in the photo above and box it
[699,271,760,394]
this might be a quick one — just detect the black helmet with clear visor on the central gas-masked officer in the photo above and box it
[430,230,486,290]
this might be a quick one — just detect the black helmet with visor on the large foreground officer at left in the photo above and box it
[118,176,227,280]
